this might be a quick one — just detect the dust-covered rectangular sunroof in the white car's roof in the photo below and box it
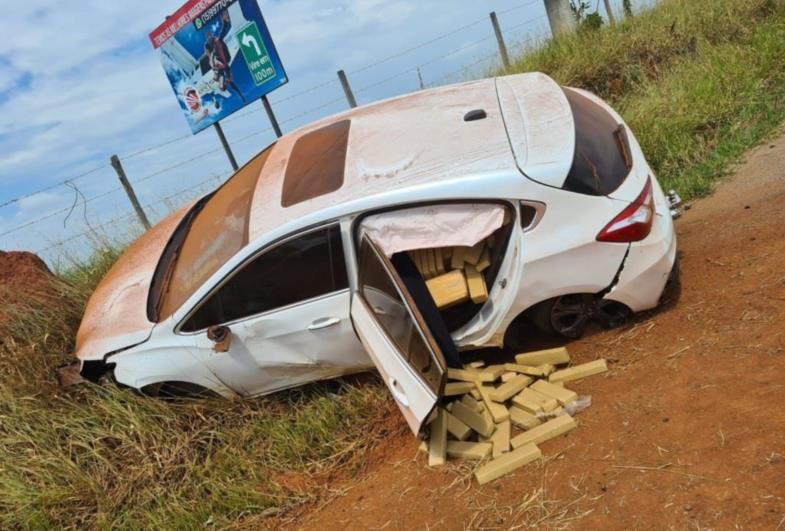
[281,120,351,208]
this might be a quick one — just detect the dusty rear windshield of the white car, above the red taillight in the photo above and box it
[562,87,632,195]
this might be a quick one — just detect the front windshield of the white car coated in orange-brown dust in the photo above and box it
[156,146,273,321]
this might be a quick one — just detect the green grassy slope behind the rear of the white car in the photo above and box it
[496,0,785,199]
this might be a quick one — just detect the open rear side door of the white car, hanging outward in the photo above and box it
[351,235,447,435]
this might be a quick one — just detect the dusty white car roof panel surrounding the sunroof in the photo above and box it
[248,79,515,241]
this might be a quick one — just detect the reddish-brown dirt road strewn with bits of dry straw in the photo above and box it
[279,130,785,530]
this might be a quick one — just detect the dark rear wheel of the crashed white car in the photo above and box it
[532,293,630,339]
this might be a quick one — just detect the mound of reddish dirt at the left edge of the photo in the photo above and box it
[0,251,55,325]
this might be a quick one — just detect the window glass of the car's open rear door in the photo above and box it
[359,240,444,393]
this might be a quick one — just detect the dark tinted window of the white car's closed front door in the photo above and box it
[181,225,349,332]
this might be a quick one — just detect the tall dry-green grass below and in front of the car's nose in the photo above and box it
[0,250,402,529]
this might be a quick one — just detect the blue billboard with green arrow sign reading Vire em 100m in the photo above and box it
[150,0,288,134]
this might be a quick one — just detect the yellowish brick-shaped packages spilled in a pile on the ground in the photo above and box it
[422,348,607,485]
